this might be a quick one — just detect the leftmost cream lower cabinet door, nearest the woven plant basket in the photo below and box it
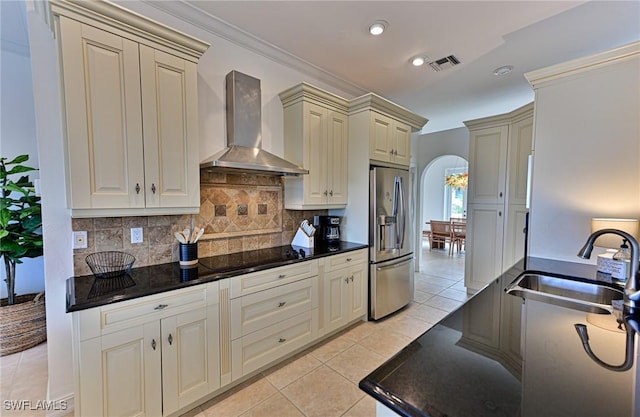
[76,322,162,417]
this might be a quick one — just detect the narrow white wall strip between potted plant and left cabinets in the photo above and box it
[27,3,73,406]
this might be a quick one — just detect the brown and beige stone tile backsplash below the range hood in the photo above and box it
[71,172,327,275]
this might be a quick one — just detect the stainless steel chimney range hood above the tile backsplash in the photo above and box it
[200,71,309,175]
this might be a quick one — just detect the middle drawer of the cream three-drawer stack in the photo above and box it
[231,277,318,339]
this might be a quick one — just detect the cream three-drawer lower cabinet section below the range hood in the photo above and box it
[230,260,319,381]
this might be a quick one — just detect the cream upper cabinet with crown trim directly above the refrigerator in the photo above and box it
[349,93,427,166]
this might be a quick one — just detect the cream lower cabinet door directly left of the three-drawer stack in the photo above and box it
[161,305,220,415]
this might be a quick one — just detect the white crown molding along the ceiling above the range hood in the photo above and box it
[142,0,367,96]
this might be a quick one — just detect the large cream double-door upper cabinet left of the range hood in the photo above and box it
[51,0,208,217]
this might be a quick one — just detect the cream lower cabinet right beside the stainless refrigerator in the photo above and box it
[323,250,368,333]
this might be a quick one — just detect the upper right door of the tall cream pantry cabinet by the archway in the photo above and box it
[508,117,533,205]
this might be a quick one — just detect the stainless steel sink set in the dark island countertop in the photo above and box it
[505,271,623,314]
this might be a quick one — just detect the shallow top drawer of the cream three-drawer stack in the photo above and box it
[230,260,318,298]
